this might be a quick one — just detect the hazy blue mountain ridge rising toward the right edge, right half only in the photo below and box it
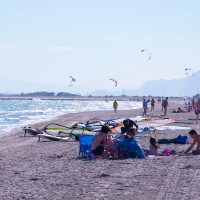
[89,71,200,97]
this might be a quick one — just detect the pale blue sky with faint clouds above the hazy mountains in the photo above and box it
[0,0,200,91]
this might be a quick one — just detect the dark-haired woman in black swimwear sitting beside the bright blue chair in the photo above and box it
[91,124,113,158]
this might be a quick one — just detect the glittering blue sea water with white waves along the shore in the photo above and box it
[0,100,142,133]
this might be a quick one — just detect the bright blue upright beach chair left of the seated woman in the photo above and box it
[79,135,94,156]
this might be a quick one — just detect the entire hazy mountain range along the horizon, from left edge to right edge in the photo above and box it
[0,71,200,96]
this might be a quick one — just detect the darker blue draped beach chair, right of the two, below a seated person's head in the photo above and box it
[115,138,145,158]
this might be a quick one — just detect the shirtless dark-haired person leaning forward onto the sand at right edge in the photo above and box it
[184,129,200,155]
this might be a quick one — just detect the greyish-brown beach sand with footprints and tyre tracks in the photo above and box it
[0,102,200,200]
